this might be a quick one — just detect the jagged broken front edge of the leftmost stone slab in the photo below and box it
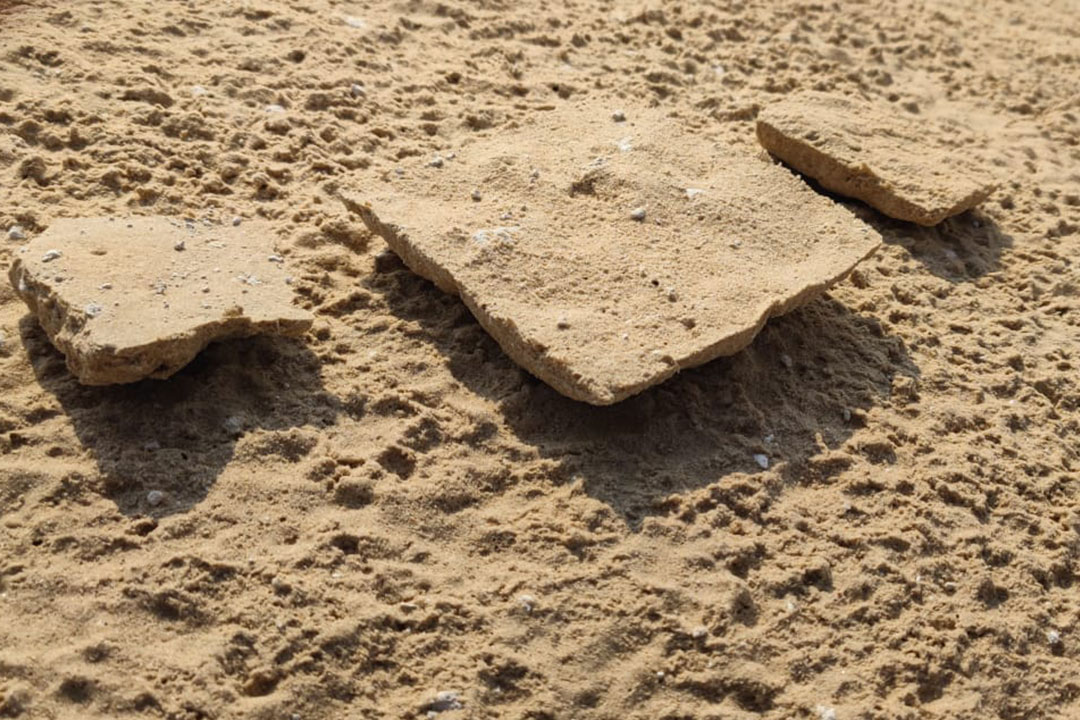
[8,258,314,385]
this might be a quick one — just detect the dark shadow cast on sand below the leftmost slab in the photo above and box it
[19,315,339,517]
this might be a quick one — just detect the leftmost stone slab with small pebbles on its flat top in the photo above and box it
[9,217,313,385]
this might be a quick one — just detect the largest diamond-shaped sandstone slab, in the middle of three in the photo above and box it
[341,109,880,405]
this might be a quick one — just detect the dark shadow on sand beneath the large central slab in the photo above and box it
[367,262,918,529]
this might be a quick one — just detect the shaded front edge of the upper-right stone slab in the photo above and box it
[756,117,995,228]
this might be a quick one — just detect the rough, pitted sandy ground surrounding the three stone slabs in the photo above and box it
[0,0,1080,720]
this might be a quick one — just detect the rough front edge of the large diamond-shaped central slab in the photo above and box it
[339,193,881,406]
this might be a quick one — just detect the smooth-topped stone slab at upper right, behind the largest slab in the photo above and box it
[757,92,995,226]
